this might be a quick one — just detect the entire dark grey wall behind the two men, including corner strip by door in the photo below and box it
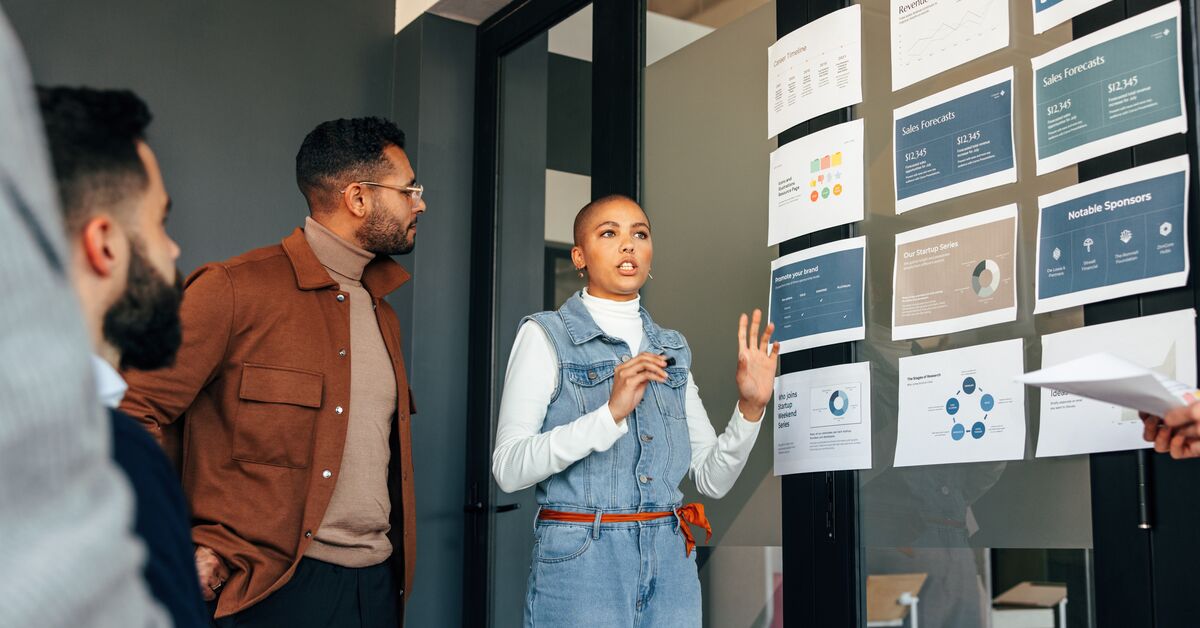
[5,0,475,626]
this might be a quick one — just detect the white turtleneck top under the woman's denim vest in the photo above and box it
[492,291,762,498]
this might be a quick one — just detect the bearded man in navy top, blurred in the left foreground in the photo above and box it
[37,88,208,628]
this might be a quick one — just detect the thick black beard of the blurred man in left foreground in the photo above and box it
[103,239,184,371]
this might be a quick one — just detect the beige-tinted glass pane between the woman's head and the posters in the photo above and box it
[643,2,784,628]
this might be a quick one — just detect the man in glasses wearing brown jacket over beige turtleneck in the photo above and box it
[121,118,425,628]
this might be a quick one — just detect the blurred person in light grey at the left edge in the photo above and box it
[0,12,170,628]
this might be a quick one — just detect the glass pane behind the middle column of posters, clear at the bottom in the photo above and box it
[854,0,1092,628]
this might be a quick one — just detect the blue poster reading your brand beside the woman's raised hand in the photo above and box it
[767,237,866,353]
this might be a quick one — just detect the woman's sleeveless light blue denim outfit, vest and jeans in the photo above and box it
[522,293,701,628]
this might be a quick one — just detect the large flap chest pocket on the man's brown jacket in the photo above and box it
[233,364,325,468]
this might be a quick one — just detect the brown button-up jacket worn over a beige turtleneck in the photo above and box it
[121,229,416,623]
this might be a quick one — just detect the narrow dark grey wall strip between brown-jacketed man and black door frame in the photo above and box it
[392,14,475,626]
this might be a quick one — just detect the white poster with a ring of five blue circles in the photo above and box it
[895,339,1025,467]
